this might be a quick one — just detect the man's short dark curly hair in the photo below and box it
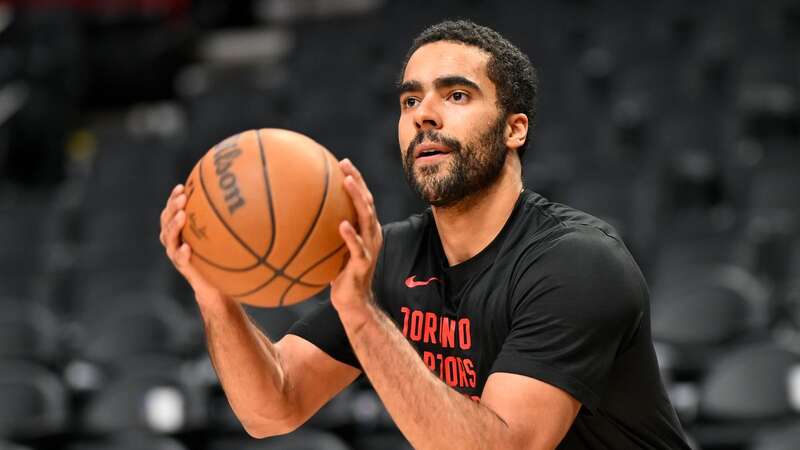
[399,20,539,159]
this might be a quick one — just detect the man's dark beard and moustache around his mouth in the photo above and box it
[403,115,508,208]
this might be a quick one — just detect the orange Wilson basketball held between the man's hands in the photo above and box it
[181,129,356,307]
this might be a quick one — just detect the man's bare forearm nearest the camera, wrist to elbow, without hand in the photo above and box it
[340,302,516,449]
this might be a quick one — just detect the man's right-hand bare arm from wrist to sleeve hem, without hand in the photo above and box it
[340,303,581,450]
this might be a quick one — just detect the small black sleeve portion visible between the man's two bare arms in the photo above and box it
[288,300,361,369]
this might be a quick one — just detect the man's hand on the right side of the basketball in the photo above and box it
[331,159,383,328]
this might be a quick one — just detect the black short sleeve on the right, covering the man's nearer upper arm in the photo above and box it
[492,227,647,409]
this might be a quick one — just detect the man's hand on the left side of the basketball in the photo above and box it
[159,184,226,306]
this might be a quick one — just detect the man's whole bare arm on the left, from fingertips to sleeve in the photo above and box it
[160,185,359,437]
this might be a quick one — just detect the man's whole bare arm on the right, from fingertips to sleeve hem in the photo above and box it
[331,161,580,449]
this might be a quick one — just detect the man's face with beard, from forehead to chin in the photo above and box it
[397,41,508,207]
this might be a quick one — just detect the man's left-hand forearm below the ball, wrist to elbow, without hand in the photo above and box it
[198,299,294,436]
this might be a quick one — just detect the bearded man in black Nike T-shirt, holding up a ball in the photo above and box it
[161,21,688,449]
